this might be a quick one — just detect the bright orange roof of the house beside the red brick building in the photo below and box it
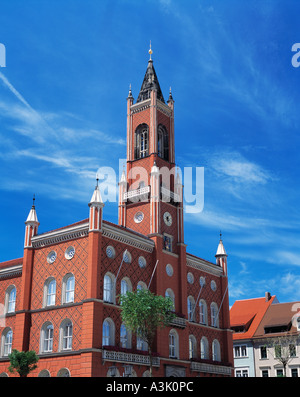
[230,295,277,340]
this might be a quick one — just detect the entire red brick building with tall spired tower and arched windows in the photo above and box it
[0,50,233,377]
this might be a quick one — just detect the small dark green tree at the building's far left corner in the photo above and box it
[8,349,39,378]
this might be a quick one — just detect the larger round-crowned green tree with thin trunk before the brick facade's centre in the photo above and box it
[120,289,175,376]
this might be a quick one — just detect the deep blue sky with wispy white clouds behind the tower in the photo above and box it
[0,0,300,304]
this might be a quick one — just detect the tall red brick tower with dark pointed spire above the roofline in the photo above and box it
[119,48,184,253]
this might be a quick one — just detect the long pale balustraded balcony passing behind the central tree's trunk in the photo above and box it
[102,346,160,367]
